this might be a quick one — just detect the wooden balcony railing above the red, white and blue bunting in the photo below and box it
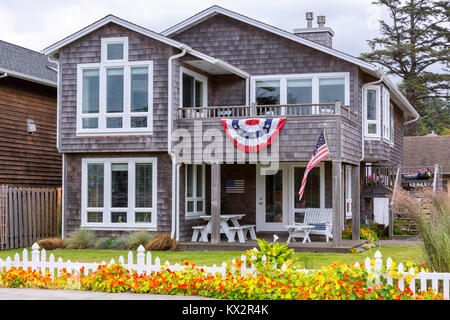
[178,101,350,119]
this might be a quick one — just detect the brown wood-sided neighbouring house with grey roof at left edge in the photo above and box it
[0,41,62,187]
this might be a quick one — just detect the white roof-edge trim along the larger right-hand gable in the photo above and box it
[161,5,419,118]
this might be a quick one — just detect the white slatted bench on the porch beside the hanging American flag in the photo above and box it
[285,208,333,242]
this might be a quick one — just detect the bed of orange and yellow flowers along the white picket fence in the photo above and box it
[0,260,443,300]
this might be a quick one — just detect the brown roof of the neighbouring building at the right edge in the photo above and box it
[403,135,450,195]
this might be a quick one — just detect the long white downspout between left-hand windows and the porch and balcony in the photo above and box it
[167,47,187,238]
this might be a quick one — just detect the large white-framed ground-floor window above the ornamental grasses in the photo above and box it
[82,158,157,230]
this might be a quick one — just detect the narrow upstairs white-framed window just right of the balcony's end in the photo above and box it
[363,86,381,139]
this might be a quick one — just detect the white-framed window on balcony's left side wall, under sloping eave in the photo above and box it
[180,67,208,107]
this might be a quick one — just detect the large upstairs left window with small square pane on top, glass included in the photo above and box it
[77,38,153,135]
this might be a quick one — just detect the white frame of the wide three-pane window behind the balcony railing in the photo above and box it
[250,72,350,114]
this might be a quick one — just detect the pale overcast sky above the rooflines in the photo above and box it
[0,0,387,56]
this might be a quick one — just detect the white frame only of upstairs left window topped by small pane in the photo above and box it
[76,38,153,136]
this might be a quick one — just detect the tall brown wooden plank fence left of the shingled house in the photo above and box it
[0,186,61,250]
